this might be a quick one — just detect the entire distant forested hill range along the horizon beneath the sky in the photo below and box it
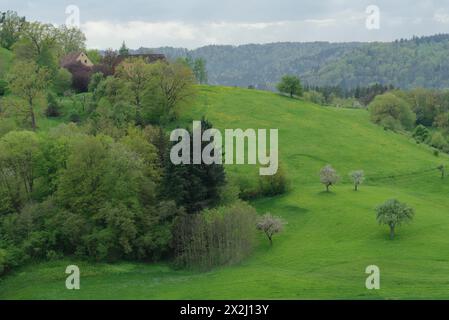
[135,34,449,89]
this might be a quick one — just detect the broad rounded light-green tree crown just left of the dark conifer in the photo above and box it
[57,136,142,214]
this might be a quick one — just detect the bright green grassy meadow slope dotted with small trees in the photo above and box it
[0,87,449,299]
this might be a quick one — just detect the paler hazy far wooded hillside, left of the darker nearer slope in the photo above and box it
[147,42,363,91]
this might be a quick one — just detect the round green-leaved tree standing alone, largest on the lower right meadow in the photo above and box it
[376,199,415,240]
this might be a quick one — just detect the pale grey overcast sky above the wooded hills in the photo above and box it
[0,0,449,49]
